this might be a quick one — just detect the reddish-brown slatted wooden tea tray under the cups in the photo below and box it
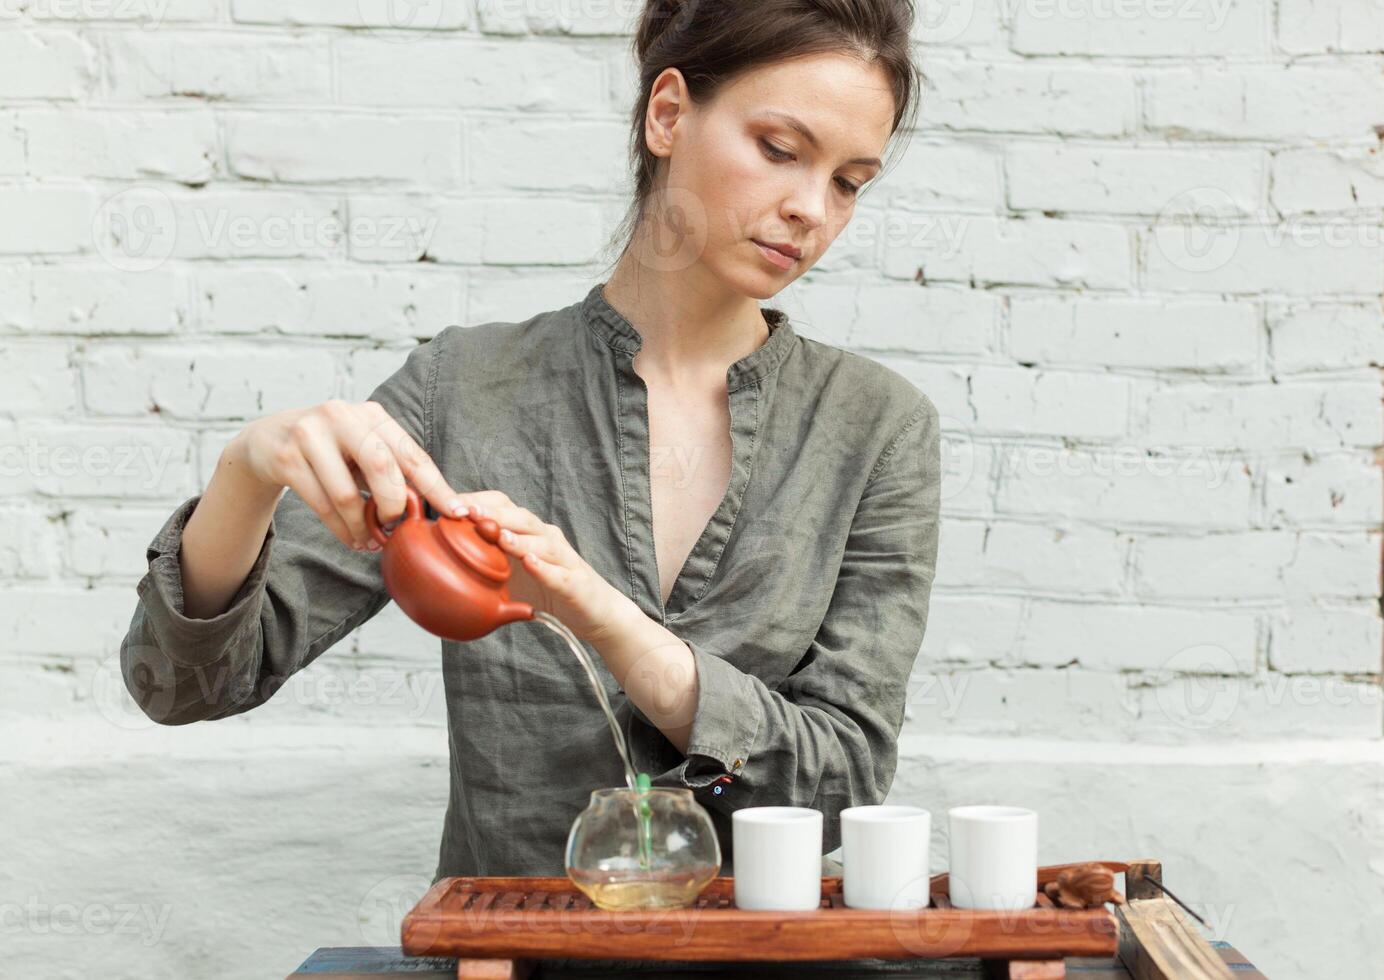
[401,861,1201,980]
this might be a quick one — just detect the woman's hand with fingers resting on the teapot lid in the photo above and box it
[461,490,626,642]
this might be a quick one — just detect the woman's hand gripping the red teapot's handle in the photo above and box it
[224,399,471,551]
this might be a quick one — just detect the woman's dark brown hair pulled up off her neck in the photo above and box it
[600,0,920,266]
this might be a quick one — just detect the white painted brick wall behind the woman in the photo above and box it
[0,0,1384,977]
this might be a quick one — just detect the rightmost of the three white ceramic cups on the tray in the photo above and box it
[947,806,1038,911]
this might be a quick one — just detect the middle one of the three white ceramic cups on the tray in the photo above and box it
[841,804,933,909]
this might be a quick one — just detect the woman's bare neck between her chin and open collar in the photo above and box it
[602,232,770,386]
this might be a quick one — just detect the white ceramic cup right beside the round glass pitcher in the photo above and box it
[731,807,822,912]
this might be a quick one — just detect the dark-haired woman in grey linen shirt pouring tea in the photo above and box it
[122,0,940,878]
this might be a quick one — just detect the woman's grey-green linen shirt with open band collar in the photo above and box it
[120,284,941,880]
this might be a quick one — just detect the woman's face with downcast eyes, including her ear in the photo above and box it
[646,54,894,299]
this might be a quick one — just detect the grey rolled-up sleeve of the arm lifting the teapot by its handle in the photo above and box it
[120,328,451,725]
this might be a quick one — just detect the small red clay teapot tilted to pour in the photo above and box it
[365,487,534,641]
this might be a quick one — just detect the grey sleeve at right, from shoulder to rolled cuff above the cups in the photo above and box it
[636,396,941,851]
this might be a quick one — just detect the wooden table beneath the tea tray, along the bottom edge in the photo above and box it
[280,941,1265,980]
